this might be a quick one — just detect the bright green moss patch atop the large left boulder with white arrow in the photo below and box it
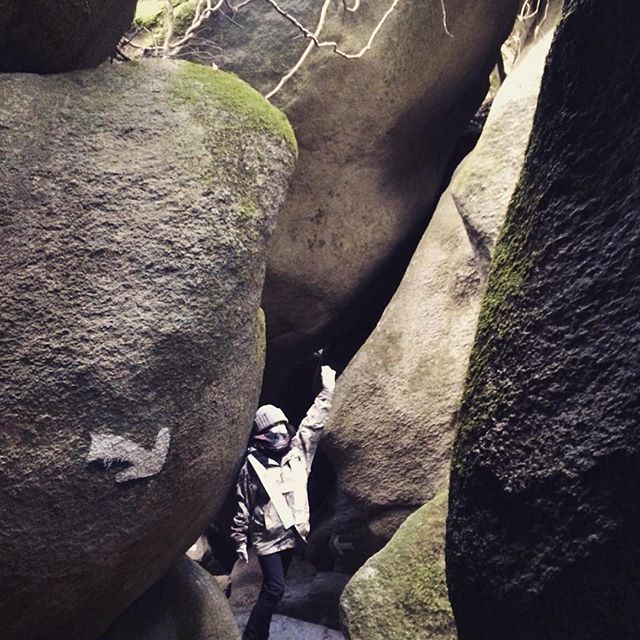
[172,62,298,154]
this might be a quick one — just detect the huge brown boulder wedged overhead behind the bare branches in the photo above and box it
[136,0,519,390]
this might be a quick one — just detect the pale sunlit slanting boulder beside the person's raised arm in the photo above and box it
[314,27,550,564]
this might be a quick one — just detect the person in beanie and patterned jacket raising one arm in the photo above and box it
[231,365,336,640]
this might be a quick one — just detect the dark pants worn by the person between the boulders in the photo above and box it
[242,549,293,640]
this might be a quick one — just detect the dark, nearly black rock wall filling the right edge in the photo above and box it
[447,0,640,640]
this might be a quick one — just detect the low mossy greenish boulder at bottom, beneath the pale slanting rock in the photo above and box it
[340,490,457,640]
